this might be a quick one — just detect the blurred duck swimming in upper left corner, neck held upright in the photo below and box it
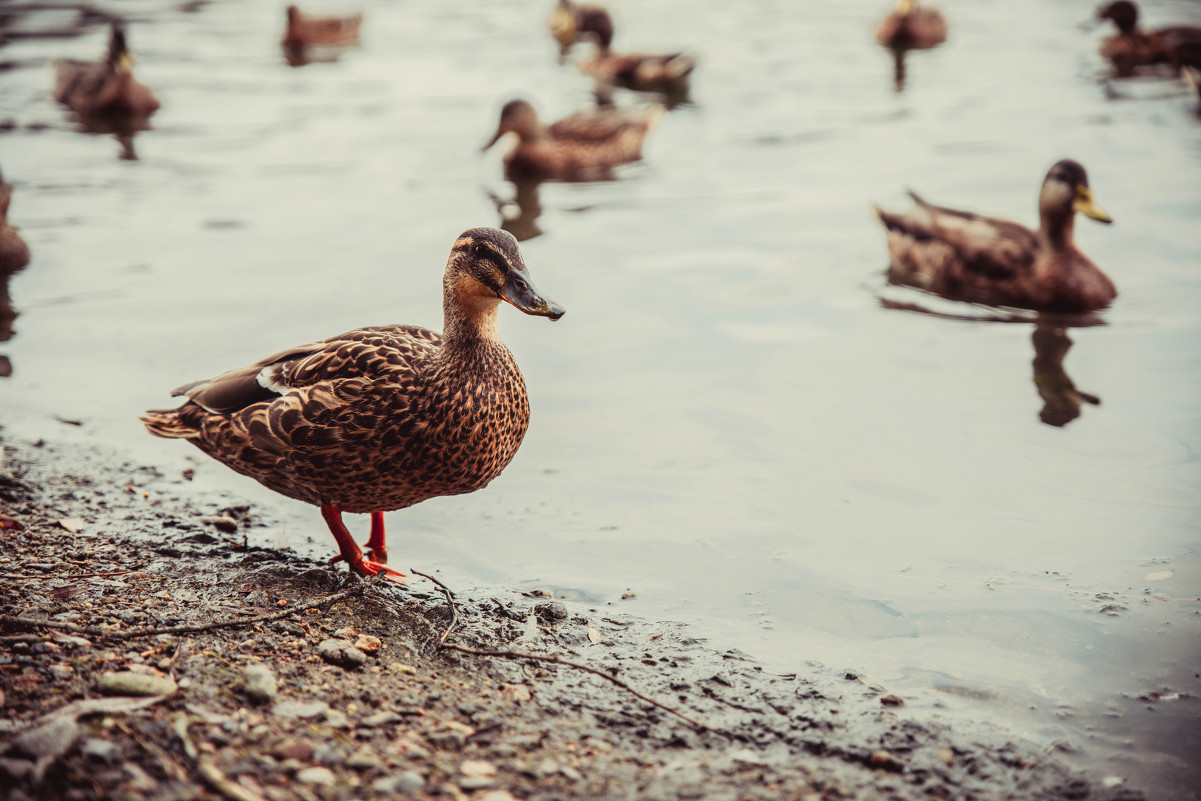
[53,22,159,119]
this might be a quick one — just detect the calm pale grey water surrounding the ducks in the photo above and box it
[0,0,1201,795]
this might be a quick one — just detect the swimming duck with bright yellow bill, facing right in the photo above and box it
[876,159,1117,312]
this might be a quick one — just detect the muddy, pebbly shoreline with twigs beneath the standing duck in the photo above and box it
[0,431,1148,801]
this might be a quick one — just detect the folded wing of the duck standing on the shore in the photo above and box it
[172,325,441,416]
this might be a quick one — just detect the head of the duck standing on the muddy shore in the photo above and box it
[443,228,564,319]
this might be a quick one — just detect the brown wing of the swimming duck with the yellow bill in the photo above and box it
[878,192,1039,280]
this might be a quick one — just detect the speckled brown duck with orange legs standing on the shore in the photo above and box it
[142,228,563,575]
